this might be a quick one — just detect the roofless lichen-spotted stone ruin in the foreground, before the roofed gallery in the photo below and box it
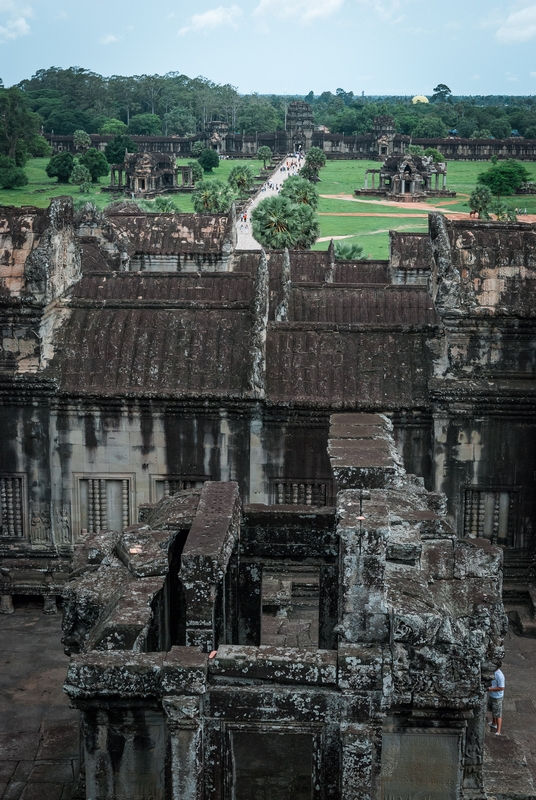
[60,414,505,800]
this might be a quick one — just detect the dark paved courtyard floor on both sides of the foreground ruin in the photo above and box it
[0,602,536,800]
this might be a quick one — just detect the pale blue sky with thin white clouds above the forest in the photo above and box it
[0,0,536,95]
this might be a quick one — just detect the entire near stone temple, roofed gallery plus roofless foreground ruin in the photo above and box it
[0,198,536,800]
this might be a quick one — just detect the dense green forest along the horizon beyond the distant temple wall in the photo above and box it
[3,67,536,139]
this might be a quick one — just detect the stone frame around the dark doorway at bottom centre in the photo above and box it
[221,719,326,800]
